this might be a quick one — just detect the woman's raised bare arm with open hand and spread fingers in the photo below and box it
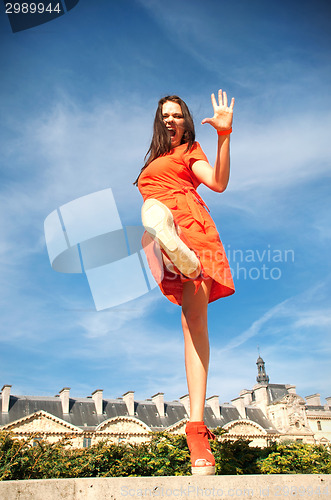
[192,90,234,193]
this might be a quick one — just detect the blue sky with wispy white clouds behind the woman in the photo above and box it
[0,0,331,402]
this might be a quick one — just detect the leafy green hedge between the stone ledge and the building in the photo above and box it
[0,432,331,480]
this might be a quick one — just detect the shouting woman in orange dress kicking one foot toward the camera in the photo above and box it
[136,90,234,475]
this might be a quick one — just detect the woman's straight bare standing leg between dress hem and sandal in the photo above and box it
[182,279,212,422]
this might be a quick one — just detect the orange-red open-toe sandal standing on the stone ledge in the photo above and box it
[185,422,216,476]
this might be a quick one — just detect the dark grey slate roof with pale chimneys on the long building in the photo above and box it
[0,384,331,433]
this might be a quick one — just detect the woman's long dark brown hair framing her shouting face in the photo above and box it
[133,95,195,186]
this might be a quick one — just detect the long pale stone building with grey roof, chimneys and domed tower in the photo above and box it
[0,357,331,447]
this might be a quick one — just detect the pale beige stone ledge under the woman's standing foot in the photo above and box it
[0,474,331,500]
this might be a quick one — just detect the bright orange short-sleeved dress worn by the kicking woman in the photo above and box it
[138,142,235,305]
